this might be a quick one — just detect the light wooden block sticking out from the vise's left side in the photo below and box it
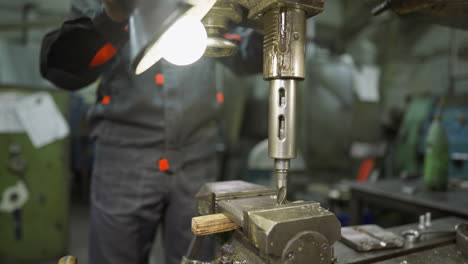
[192,214,240,236]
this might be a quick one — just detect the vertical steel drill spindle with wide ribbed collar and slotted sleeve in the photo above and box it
[263,7,306,200]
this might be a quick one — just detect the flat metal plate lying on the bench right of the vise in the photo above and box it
[341,225,405,251]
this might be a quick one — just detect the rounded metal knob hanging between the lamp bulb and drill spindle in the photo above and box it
[202,0,242,57]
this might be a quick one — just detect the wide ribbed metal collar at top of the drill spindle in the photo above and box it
[263,7,306,80]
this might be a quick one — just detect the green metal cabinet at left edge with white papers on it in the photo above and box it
[0,87,70,264]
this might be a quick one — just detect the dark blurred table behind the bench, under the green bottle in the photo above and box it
[349,179,468,225]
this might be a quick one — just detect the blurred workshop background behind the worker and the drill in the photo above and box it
[0,0,468,263]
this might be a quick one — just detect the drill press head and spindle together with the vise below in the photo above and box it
[182,0,340,264]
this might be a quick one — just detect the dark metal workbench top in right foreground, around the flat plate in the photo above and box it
[334,217,468,264]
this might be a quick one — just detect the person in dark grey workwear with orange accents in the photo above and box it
[40,0,226,264]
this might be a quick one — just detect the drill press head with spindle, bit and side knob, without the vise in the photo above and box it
[203,0,324,204]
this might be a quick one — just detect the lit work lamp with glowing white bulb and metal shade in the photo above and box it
[129,0,216,74]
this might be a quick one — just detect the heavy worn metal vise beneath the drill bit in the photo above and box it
[193,181,340,264]
